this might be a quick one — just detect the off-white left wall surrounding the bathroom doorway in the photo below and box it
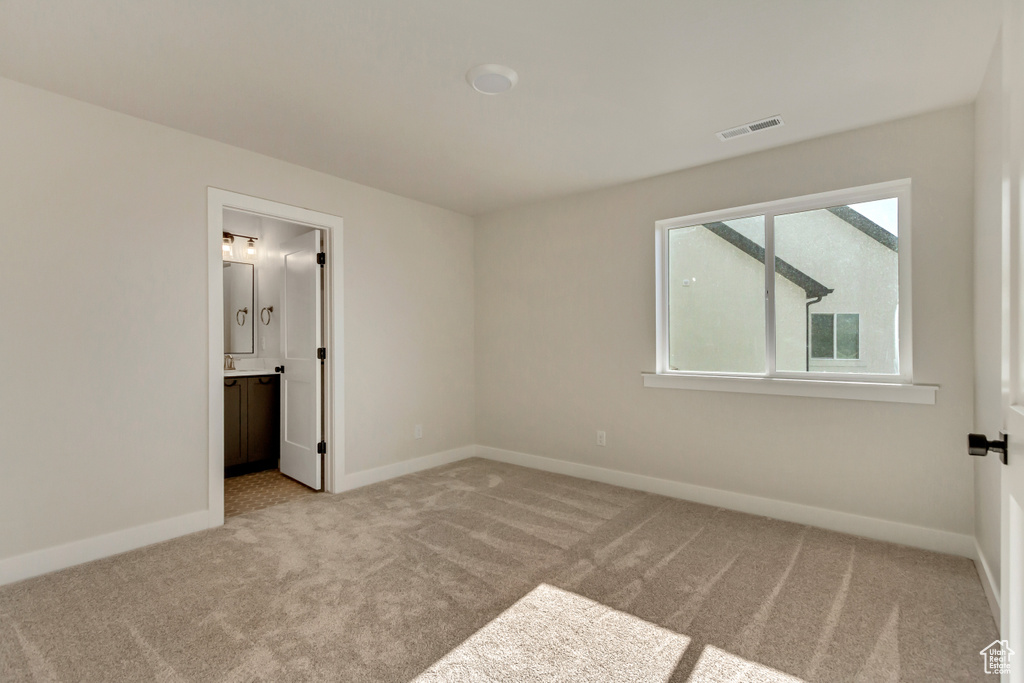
[0,80,474,559]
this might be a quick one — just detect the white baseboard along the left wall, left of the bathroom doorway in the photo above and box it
[0,510,210,586]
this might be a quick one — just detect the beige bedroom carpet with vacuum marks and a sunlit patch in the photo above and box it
[0,459,996,683]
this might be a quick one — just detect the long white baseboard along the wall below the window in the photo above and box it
[477,445,975,559]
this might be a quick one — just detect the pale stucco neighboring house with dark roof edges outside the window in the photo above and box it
[669,200,899,375]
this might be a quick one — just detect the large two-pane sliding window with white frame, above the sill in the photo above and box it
[645,180,912,397]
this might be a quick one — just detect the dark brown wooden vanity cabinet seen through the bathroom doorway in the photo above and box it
[224,375,281,476]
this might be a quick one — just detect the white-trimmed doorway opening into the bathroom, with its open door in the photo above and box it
[208,192,344,526]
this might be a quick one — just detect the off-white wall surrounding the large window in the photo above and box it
[476,105,974,535]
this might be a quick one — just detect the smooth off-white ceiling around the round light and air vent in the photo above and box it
[0,0,999,214]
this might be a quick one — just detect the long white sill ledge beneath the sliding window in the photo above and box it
[643,373,939,405]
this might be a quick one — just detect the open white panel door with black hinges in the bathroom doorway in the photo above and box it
[281,230,324,489]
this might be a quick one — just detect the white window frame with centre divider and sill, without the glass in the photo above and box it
[644,178,937,403]
